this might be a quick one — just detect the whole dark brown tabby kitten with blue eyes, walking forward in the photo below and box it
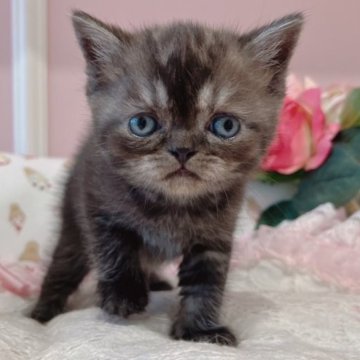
[32,11,303,345]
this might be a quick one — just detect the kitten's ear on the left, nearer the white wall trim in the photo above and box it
[72,10,131,81]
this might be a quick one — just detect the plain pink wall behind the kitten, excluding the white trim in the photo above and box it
[0,0,360,156]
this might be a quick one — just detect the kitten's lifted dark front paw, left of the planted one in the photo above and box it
[101,285,149,318]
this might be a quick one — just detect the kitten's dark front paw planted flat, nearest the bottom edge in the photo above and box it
[170,323,238,346]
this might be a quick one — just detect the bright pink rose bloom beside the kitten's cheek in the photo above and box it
[262,87,340,174]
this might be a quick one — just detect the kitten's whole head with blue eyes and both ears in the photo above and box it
[73,11,303,200]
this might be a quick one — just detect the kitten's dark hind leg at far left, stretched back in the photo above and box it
[30,224,89,323]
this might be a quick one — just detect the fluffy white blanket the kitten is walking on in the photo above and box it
[0,261,360,360]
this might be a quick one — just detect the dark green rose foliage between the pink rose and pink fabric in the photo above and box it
[258,127,360,226]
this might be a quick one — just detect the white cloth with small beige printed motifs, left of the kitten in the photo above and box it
[0,153,67,262]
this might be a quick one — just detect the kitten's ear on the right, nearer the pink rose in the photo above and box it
[240,13,304,92]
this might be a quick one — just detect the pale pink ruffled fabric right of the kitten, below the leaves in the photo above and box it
[232,204,360,292]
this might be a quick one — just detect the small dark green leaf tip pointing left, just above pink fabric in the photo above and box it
[257,200,301,227]
